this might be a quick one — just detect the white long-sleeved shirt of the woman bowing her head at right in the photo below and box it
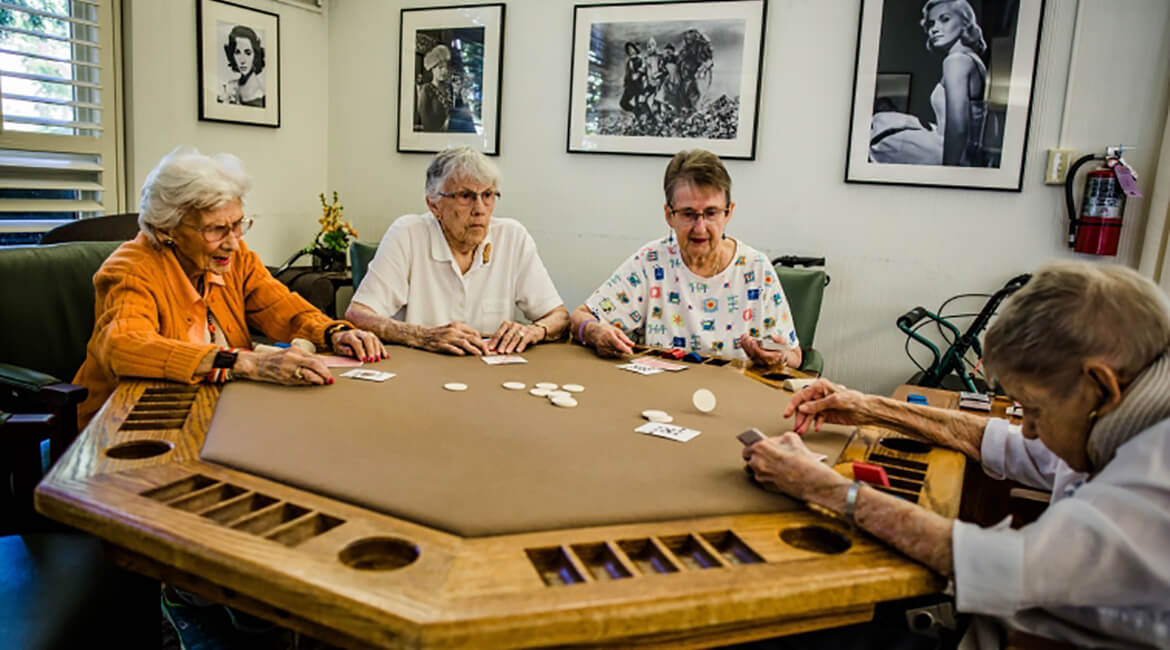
[952,420,1170,648]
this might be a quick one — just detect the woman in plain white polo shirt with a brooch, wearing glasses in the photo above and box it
[345,147,569,355]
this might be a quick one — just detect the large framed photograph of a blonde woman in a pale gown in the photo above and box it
[845,0,1044,192]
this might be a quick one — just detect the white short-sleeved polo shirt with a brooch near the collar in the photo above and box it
[353,213,564,334]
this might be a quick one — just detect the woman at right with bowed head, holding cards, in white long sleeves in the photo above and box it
[743,262,1170,648]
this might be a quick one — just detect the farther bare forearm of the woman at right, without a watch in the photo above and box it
[863,395,987,461]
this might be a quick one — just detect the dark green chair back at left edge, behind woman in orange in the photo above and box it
[0,242,122,381]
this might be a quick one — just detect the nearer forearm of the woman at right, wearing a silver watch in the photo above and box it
[806,477,955,575]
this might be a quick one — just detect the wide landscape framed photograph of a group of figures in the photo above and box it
[567,0,766,160]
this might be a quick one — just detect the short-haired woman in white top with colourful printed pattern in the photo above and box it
[572,150,801,367]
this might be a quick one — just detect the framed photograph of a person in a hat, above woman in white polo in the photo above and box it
[398,2,504,155]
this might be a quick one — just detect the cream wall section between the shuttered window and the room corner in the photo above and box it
[124,0,329,264]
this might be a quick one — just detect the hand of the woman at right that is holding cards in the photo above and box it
[743,431,842,500]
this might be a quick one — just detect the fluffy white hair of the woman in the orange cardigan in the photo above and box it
[138,146,252,244]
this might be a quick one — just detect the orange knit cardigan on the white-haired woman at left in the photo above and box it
[74,233,340,428]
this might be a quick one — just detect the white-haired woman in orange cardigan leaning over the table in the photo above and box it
[74,147,386,427]
